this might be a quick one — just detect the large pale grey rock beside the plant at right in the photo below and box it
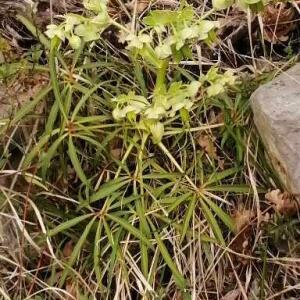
[251,63,300,194]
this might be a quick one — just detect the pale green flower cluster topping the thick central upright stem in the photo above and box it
[124,6,219,62]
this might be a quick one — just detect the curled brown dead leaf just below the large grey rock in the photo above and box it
[265,189,298,216]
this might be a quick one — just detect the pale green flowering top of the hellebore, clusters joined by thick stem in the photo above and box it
[46,0,234,166]
